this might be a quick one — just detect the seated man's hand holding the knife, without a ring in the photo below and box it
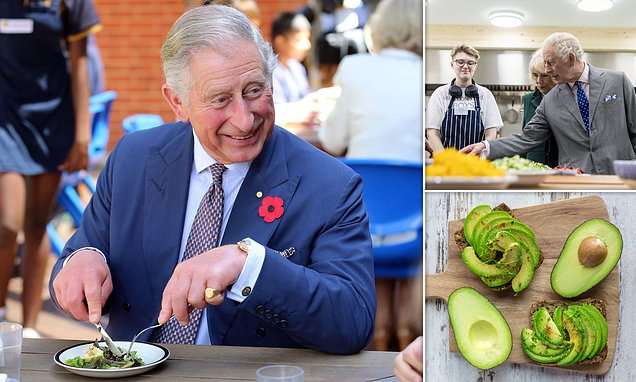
[53,250,113,323]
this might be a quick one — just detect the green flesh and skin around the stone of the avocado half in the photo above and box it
[550,218,623,298]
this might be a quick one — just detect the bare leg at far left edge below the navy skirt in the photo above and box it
[0,172,26,320]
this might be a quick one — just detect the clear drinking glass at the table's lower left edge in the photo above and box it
[0,322,22,382]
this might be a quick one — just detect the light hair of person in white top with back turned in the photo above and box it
[369,0,424,56]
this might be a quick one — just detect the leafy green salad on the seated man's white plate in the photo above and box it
[64,340,144,369]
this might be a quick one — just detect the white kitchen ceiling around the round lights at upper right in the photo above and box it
[425,0,636,29]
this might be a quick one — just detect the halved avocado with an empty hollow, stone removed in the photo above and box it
[448,287,512,369]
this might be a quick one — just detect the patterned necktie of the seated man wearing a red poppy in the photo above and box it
[156,163,227,344]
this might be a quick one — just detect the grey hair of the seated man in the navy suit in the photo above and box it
[161,5,277,103]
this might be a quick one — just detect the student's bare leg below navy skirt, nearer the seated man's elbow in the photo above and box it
[22,173,60,328]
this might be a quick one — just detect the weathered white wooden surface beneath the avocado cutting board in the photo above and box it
[424,191,636,382]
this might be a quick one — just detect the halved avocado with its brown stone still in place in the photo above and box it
[550,219,623,298]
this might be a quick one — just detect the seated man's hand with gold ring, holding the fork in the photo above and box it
[158,244,247,325]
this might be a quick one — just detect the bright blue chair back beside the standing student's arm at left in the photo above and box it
[88,90,117,165]
